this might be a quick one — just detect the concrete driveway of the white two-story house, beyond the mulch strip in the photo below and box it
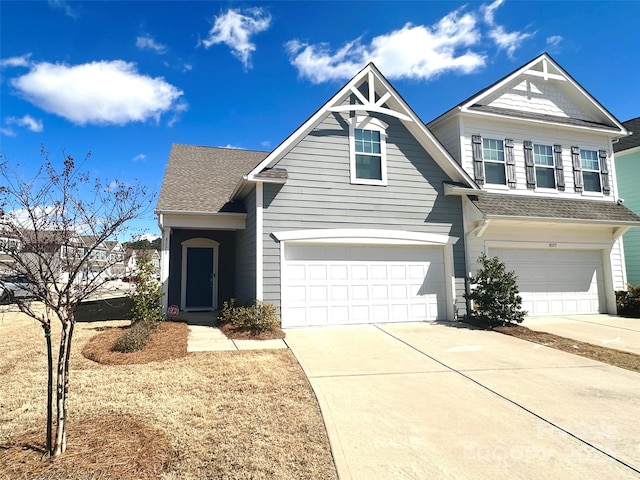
[523,315,640,355]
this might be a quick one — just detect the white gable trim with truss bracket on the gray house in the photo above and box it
[234,63,478,196]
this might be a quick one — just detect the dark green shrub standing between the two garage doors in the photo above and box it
[464,253,527,328]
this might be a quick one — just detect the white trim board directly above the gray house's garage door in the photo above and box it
[273,228,458,245]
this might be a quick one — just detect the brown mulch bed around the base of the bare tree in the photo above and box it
[0,415,176,480]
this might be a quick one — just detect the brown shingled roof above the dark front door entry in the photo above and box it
[156,144,269,213]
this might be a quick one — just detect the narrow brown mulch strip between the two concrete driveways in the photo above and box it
[493,325,640,372]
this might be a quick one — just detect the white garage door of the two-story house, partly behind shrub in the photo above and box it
[489,249,605,315]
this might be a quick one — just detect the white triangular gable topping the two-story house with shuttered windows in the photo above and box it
[429,53,628,136]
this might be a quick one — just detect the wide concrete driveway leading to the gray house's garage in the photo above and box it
[286,323,640,480]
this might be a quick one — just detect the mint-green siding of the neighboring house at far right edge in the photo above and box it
[616,151,640,285]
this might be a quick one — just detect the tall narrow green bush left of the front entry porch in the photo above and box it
[129,258,164,323]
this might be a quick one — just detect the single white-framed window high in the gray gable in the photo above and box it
[350,117,387,185]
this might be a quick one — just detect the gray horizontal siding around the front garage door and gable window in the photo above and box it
[263,114,465,316]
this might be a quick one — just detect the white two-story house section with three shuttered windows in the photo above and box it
[428,54,638,315]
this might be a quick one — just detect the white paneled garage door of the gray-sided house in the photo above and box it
[281,244,446,327]
